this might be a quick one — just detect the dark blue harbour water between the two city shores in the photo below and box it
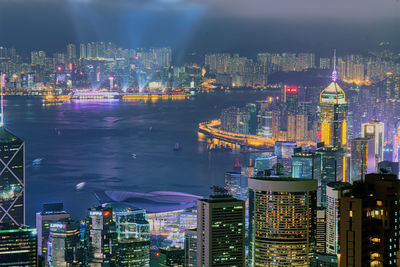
[5,92,267,225]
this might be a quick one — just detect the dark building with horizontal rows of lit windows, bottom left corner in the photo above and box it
[0,224,38,267]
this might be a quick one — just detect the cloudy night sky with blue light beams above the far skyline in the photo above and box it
[0,0,400,55]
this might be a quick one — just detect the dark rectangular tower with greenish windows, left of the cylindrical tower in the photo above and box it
[197,194,245,267]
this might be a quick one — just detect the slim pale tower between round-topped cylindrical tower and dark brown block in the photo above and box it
[326,181,351,257]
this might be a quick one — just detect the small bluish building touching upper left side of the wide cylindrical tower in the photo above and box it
[225,172,248,201]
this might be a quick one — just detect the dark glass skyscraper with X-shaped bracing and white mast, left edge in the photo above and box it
[0,74,25,226]
